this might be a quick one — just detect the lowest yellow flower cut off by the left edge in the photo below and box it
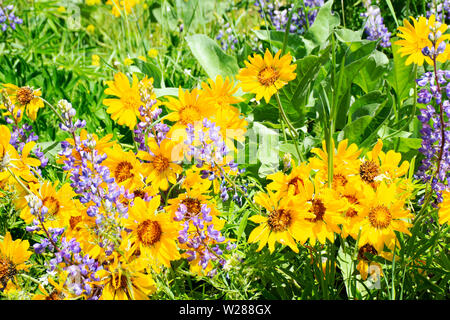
[0,232,32,290]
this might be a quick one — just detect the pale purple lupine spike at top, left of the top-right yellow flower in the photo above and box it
[361,1,391,48]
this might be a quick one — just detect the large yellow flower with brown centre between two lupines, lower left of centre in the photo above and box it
[124,196,180,268]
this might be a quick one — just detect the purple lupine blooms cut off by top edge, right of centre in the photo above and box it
[255,0,324,34]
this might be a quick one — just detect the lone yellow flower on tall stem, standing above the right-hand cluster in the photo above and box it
[236,49,297,103]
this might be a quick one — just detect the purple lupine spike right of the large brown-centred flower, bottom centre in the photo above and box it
[174,203,233,276]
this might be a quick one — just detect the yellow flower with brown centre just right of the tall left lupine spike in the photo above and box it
[103,144,143,192]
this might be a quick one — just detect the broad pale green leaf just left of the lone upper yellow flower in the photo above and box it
[186,34,239,79]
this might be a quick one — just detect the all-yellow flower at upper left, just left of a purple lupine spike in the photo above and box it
[103,72,142,130]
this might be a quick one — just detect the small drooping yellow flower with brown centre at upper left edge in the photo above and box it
[3,83,44,121]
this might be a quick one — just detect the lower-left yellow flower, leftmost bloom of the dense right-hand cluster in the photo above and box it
[248,190,314,253]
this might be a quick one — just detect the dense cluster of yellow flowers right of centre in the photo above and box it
[248,140,412,274]
